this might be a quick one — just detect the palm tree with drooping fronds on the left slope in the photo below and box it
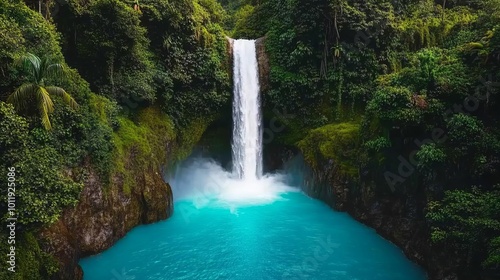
[7,53,78,130]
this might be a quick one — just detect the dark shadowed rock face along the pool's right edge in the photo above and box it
[305,163,480,280]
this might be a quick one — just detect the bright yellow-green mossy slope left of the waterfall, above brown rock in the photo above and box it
[112,107,214,193]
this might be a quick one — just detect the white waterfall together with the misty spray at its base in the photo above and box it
[169,40,299,206]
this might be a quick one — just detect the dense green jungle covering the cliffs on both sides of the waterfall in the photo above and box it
[0,0,500,279]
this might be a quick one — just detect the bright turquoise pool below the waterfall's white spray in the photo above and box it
[80,173,426,280]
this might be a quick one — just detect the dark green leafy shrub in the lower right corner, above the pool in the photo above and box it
[426,186,500,268]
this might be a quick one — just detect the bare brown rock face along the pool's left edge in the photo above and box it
[40,165,173,280]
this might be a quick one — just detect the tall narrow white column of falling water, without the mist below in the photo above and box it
[231,40,262,180]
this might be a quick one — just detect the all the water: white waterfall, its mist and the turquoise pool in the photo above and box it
[80,40,426,280]
